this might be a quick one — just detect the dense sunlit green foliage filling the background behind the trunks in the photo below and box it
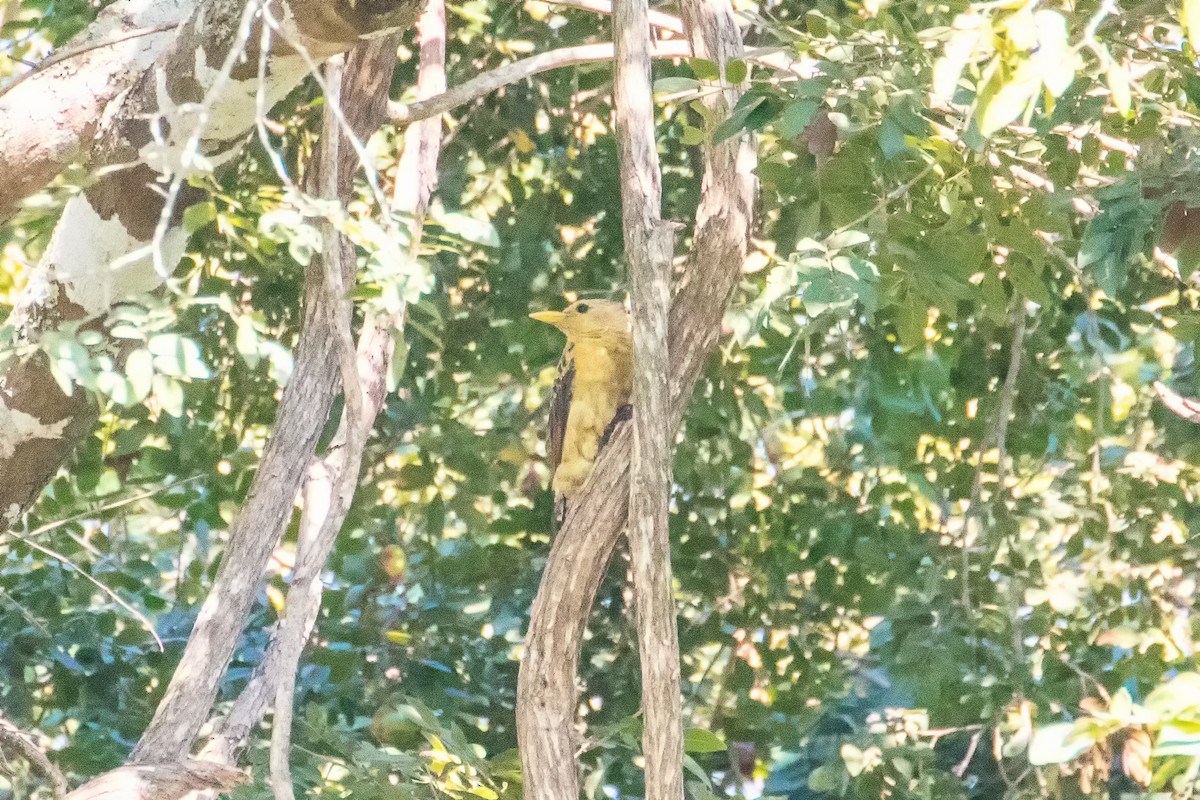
[7,0,1200,799]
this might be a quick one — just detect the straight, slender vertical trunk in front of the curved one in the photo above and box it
[612,0,683,800]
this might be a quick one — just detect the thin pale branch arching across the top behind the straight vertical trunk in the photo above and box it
[388,42,691,125]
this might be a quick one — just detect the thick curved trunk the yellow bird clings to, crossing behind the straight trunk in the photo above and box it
[517,0,757,800]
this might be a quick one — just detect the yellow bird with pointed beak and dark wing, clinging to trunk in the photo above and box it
[529,300,634,498]
